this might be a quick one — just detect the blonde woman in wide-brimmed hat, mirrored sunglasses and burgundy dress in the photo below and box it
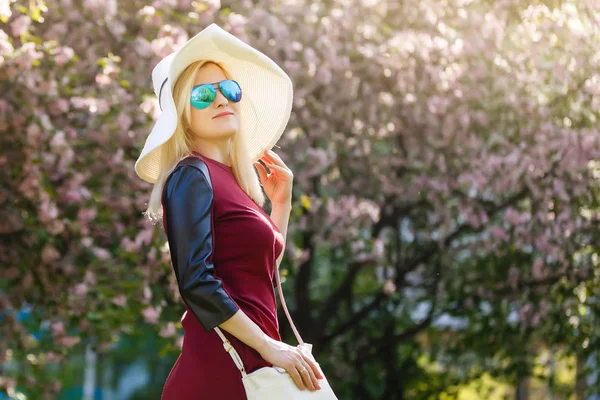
[135,24,323,400]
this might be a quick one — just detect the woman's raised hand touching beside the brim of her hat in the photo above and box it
[254,150,294,205]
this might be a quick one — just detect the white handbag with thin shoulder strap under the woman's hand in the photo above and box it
[215,266,337,400]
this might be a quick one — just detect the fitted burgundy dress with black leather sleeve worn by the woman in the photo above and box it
[161,152,284,400]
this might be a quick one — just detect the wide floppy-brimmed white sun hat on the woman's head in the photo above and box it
[135,24,293,183]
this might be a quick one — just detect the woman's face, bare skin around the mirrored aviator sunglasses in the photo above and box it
[190,63,243,139]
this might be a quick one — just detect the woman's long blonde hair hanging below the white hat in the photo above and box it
[143,60,265,224]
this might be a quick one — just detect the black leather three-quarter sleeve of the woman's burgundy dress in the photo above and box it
[162,161,239,332]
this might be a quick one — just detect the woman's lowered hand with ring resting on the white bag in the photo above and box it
[258,338,323,390]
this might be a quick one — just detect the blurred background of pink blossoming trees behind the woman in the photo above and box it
[0,0,600,400]
